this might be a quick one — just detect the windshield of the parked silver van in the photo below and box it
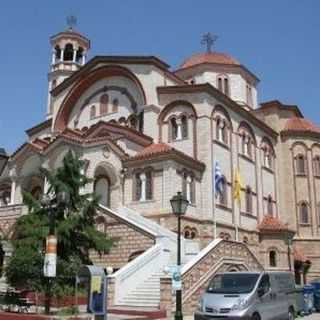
[207,273,259,294]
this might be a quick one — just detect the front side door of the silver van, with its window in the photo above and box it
[255,274,276,320]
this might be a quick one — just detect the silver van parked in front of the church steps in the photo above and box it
[194,272,296,320]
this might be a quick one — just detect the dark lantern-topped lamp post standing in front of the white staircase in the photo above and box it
[170,192,189,320]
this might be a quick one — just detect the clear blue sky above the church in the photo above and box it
[0,0,320,152]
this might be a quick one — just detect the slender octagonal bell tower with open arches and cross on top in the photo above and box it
[47,16,90,119]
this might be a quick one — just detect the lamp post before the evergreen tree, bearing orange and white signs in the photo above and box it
[41,191,70,314]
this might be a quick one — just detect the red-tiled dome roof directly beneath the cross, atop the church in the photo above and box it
[180,52,240,69]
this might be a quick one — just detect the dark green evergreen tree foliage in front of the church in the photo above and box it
[6,151,112,291]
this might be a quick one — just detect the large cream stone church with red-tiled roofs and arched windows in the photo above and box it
[0,26,320,312]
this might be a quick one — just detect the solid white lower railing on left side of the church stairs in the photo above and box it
[111,244,170,304]
